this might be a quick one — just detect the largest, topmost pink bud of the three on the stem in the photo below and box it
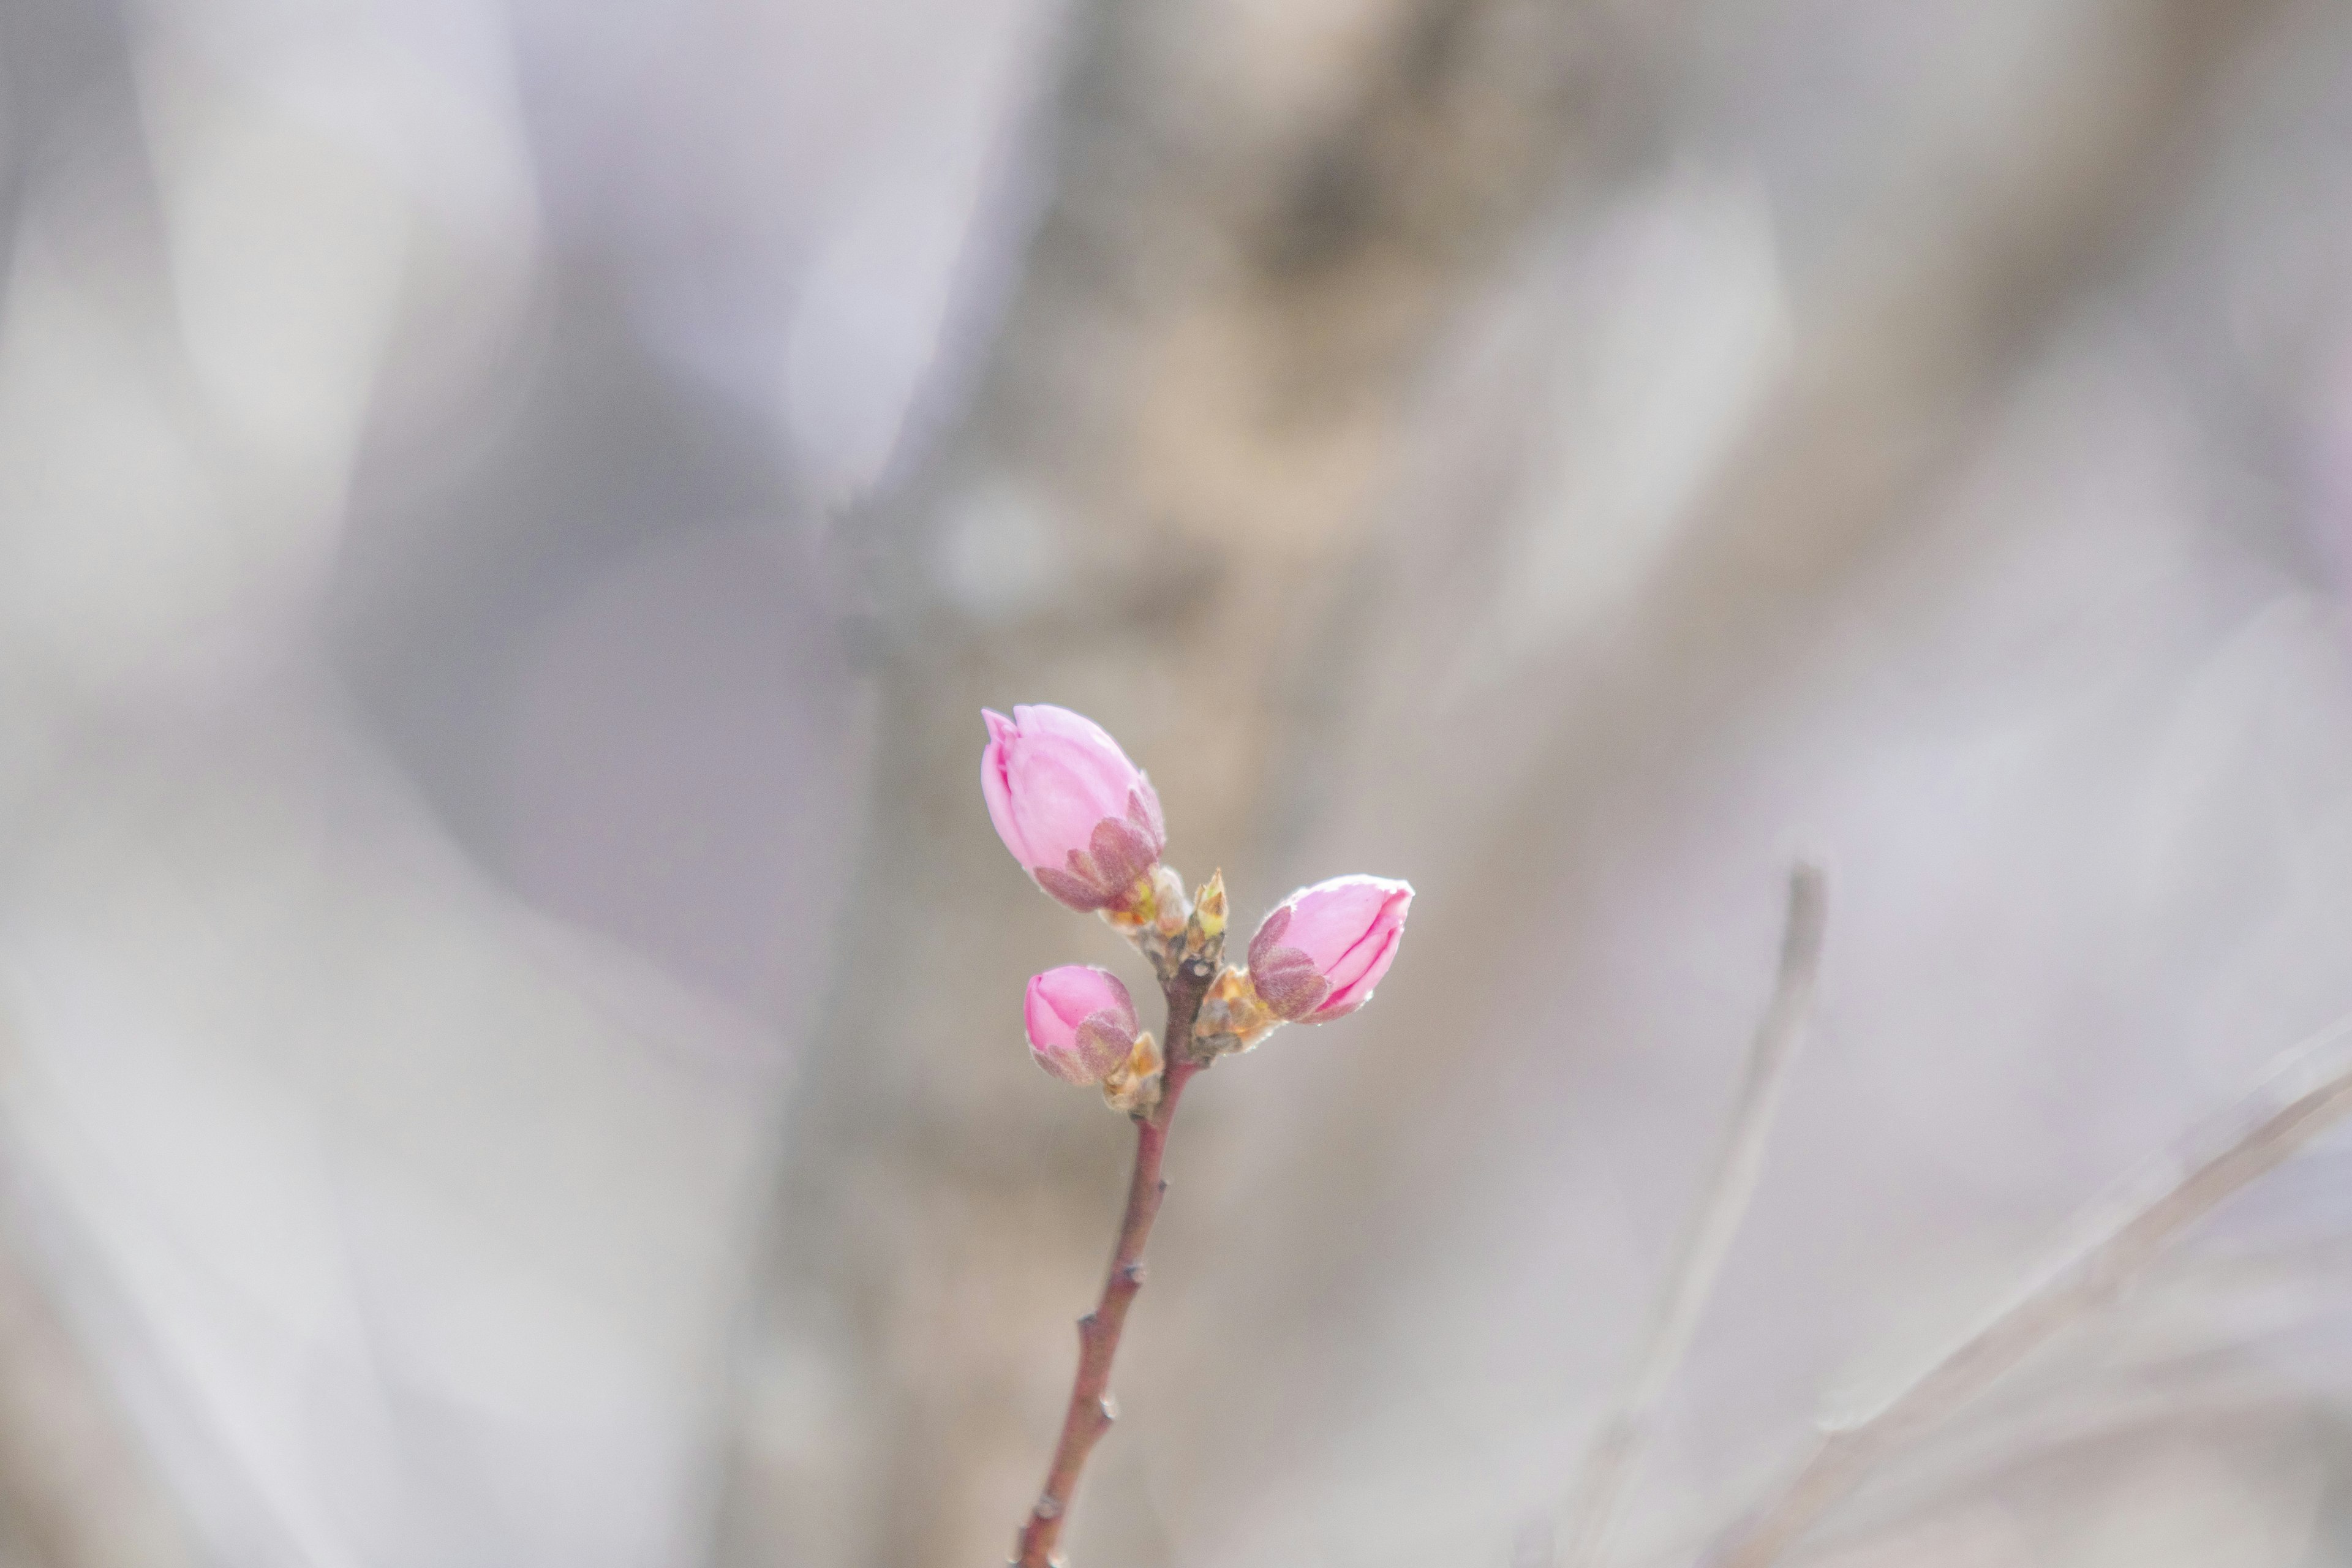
[981,703,1169,910]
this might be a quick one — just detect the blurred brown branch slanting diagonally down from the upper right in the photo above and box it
[1157,2,2314,1542]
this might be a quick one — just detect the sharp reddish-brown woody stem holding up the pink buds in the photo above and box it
[1014,959,1216,1568]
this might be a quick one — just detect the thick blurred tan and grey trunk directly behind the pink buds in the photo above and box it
[725,0,1627,1563]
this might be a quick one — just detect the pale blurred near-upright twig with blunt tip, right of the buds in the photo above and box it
[1566,865,1828,1568]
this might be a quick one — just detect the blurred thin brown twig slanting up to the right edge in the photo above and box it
[1703,1018,2352,1568]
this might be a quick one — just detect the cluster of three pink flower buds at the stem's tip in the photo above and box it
[981,703,1414,1114]
